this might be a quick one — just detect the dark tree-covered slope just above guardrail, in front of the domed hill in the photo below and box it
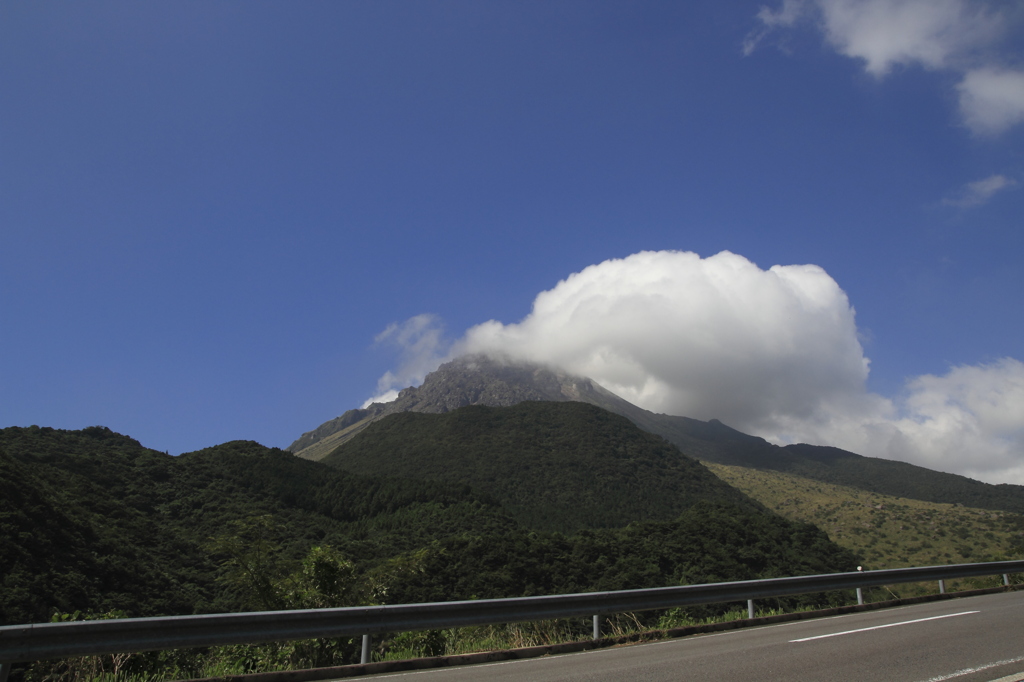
[391,502,857,603]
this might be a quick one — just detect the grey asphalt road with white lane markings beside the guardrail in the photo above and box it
[373,592,1024,682]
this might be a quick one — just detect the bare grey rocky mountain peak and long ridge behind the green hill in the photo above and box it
[288,355,1024,513]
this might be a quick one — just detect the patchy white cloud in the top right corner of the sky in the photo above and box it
[743,0,1024,134]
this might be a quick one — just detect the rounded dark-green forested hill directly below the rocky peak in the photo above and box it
[322,401,759,532]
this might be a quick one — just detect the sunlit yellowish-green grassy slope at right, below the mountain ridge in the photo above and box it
[707,464,1024,569]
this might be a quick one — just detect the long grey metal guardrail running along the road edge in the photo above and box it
[0,561,1024,671]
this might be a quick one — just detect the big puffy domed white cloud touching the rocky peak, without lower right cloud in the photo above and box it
[457,252,867,429]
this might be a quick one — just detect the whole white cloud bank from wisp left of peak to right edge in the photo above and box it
[378,251,1024,483]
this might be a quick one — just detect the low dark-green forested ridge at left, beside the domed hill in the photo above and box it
[0,427,514,624]
